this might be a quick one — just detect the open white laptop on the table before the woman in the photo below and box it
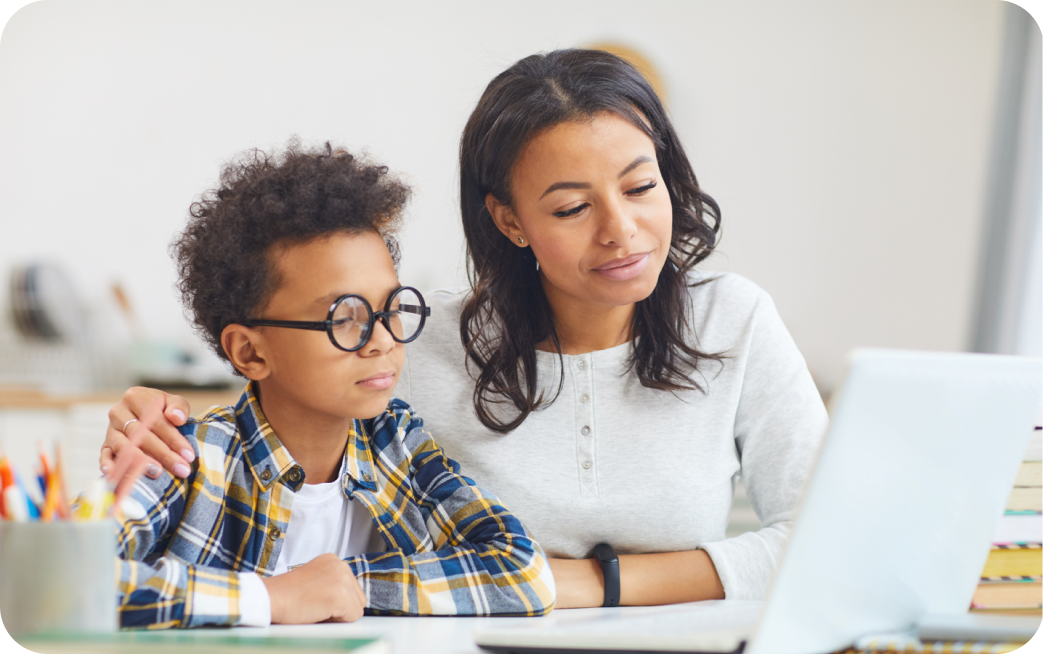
[474,349,1044,654]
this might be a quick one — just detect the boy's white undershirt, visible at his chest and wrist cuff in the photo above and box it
[239,453,387,627]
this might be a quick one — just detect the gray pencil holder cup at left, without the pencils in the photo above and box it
[0,520,117,635]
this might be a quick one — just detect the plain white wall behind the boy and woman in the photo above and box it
[0,0,1001,387]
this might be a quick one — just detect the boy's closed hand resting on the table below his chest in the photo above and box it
[261,554,366,625]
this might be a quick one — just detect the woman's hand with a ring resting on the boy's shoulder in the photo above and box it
[99,387,195,500]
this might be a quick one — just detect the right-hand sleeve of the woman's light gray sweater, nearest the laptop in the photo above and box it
[701,291,827,600]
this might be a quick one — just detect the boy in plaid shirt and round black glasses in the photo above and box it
[113,142,554,628]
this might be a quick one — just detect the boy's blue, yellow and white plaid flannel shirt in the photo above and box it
[118,384,554,628]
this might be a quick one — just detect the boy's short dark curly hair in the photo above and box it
[170,139,410,374]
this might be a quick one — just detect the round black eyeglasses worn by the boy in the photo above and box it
[246,286,431,352]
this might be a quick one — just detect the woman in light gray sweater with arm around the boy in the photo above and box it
[101,50,826,608]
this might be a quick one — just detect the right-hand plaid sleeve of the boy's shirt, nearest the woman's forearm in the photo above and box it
[365,413,554,615]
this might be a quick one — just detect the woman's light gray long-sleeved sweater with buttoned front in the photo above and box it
[396,274,827,600]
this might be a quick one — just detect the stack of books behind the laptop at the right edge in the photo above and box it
[971,425,1044,615]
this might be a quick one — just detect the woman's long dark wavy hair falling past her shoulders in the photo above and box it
[460,49,722,434]
